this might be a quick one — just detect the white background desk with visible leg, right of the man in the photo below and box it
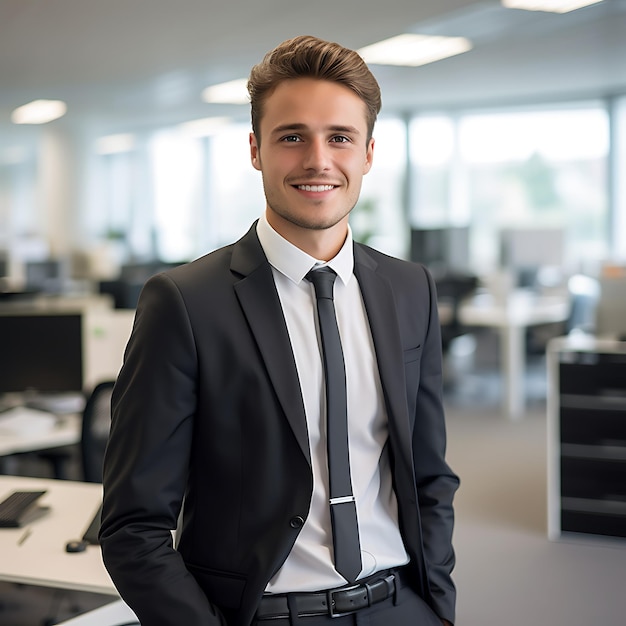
[459,290,570,419]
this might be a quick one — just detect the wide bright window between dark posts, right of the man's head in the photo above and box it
[410,103,609,272]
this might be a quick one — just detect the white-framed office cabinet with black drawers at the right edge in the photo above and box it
[548,337,626,539]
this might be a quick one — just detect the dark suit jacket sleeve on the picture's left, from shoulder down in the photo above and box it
[100,275,226,626]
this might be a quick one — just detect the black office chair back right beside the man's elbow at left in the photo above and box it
[80,380,115,483]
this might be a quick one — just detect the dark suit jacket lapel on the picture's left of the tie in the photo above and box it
[231,222,311,464]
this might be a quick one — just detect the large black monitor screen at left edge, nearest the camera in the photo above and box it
[0,314,83,393]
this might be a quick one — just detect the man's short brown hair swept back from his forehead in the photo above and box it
[248,35,381,141]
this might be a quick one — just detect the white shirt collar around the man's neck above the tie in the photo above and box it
[257,213,354,284]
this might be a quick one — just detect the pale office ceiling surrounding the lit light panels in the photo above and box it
[0,0,626,135]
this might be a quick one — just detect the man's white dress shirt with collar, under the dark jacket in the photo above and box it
[257,215,408,593]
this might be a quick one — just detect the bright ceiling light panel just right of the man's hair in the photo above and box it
[358,34,472,67]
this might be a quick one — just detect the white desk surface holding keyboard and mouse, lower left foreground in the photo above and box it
[0,476,119,597]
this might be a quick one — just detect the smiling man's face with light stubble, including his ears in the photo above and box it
[250,78,374,245]
